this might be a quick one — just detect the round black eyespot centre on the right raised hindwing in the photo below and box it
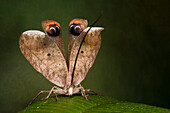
[70,24,81,36]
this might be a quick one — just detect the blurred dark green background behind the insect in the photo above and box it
[0,0,170,113]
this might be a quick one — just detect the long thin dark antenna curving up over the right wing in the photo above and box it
[71,13,103,85]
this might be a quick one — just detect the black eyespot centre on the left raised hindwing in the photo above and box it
[47,24,60,36]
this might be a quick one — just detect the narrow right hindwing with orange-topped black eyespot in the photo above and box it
[67,19,88,68]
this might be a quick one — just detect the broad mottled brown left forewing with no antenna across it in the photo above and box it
[19,30,68,87]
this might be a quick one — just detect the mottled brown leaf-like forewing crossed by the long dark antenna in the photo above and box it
[69,27,104,86]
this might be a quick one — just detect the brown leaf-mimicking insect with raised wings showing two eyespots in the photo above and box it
[19,15,104,104]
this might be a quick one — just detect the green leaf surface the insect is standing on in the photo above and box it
[19,95,170,113]
